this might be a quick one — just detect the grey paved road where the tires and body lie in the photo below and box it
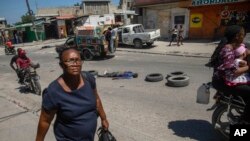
[0,41,223,141]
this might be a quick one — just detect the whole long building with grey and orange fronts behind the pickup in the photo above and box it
[134,0,250,40]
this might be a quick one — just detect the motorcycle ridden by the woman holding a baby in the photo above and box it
[197,82,246,140]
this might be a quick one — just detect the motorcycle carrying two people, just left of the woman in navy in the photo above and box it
[23,64,41,95]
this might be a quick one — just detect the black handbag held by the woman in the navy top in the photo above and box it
[97,127,116,141]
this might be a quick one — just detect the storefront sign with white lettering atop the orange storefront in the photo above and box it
[192,0,246,6]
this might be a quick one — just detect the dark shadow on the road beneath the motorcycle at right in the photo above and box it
[168,119,221,141]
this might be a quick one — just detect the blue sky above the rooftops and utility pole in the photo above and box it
[0,0,119,24]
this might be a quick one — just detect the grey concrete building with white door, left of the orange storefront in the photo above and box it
[134,0,190,38]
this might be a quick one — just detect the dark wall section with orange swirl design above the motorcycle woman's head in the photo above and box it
[220,9,250,26]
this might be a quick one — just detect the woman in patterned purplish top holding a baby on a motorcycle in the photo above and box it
[212,25,250,123]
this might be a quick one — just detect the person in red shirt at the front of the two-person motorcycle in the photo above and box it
[16,50,31,84]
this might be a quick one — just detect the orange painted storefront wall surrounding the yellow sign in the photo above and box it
[189,2,250,39]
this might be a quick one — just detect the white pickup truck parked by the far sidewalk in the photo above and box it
[117,24,161,48]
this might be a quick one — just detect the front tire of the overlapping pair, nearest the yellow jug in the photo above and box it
[166,76,189,87]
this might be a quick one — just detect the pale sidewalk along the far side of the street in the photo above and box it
[1,38,217,58]
